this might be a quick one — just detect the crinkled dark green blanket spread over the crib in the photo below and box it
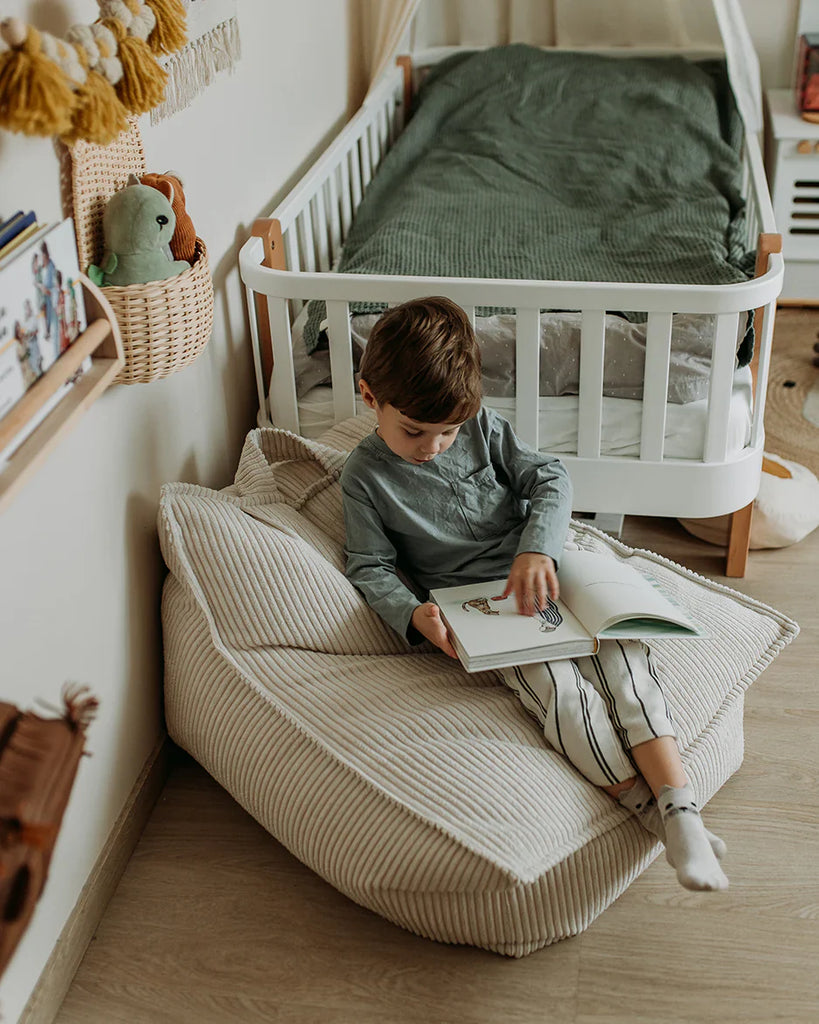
[305,45,752,361]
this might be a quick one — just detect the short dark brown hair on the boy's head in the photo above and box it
[360,295,481,423]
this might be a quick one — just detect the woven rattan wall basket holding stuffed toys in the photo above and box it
[61,119,213,384]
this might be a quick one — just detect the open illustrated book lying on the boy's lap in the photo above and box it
[430,551,707,672]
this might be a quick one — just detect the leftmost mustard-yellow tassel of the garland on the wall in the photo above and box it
[0,18,75,135]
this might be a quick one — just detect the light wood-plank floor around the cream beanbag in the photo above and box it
[52,519,819,1024]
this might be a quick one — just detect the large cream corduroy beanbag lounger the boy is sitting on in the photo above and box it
[159,417,798,956]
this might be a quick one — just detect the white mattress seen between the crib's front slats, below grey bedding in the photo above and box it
[290,367,752,459]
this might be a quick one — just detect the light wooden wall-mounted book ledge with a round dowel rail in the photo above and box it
[0,274,125,511]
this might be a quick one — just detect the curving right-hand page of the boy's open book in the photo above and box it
[558,551,702,639]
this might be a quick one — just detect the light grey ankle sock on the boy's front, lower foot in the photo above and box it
[657,785,728,891]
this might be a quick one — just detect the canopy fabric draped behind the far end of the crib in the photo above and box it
[362,0,763,132]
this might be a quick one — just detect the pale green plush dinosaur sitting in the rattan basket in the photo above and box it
[88,174,190,286]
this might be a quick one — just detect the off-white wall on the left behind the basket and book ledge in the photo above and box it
[0,0,351,1022]
